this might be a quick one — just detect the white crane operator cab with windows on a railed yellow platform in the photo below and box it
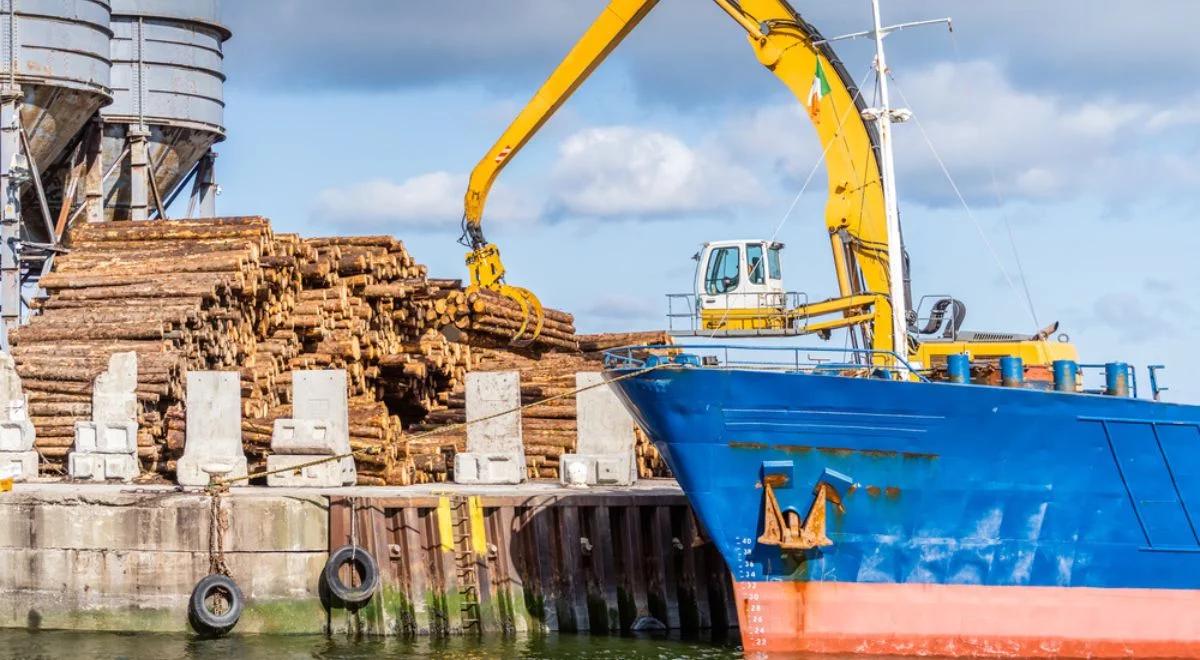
[667,240,803,336]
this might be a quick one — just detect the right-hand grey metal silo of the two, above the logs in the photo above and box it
[101,0,230,220]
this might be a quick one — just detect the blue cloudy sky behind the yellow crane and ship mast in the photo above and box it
[217,0,1200,402]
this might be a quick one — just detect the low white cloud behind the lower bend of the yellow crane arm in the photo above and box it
[313,172,538,232]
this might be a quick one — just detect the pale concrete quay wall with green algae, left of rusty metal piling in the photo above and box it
[0,484,329,632]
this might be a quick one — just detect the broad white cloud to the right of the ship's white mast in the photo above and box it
[868,61,1195,205]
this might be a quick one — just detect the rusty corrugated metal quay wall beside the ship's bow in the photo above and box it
[326,492,737,635]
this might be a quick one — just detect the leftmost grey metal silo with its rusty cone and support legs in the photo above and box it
[0,0,112,350]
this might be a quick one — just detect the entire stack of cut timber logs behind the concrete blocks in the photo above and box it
[12,217,664,485]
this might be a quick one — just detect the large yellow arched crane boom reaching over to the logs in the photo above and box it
[463,0,893,350]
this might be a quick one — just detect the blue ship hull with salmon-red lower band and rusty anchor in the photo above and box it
[608,366,1200,654]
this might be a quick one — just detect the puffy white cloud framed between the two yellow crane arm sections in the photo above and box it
[552,126,762,217]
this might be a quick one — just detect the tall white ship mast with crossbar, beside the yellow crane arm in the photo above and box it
[817,0,954,378]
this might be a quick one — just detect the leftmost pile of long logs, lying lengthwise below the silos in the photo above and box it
[13,217,288,472]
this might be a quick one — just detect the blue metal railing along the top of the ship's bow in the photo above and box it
[604,344,929,383]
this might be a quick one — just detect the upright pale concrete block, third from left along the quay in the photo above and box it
[175,371,246,486]
